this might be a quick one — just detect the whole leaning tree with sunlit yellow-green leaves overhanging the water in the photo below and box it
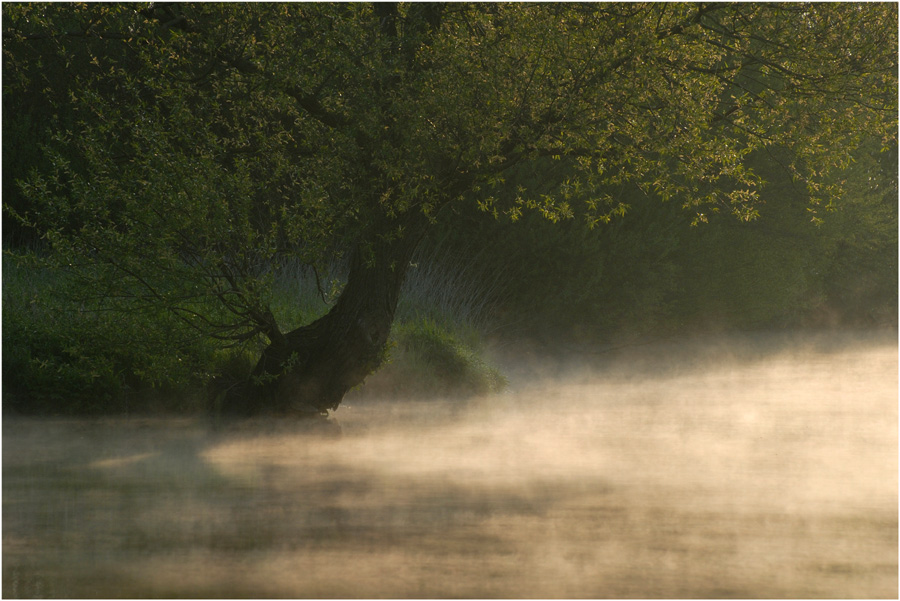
[3,3,897,412]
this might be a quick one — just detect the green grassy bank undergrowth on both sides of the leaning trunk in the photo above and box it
[2,246,505,415]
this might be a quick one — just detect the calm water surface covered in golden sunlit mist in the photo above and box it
[3,333,898,598]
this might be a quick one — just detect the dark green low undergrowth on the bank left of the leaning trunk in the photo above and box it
[3,253,235,414]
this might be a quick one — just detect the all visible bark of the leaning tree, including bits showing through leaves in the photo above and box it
[214,3,443,415]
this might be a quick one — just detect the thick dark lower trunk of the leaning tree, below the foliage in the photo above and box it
[221,213,425,416]
